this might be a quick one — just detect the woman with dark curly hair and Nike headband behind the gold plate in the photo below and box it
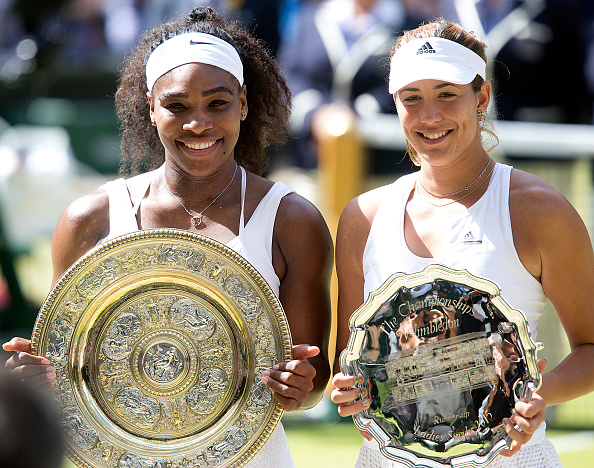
[4,7,332,468]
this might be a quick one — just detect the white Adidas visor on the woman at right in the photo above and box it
[388,37,487,94]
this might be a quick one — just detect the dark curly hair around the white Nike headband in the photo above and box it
[115,7,291,175]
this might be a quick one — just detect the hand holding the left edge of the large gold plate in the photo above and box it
[2,337,57,390]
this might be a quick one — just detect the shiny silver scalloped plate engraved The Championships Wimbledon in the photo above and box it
[341,265,542,468]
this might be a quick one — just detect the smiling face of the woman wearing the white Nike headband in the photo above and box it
[148,63,247,176]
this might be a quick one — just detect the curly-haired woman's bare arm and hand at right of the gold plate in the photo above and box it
[264,194,333,411]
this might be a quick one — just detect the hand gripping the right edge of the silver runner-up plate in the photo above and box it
[499,359,547,457]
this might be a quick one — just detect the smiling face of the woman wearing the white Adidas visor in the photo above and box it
[394,80,491,166]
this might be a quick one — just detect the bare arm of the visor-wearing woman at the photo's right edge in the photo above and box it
[510,170,594,405]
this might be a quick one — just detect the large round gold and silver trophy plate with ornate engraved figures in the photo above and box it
[32,229,291,468]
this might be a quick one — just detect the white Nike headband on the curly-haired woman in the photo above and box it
[146,33,243,91]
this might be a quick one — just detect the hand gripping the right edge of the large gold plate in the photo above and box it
[262,344,320,411]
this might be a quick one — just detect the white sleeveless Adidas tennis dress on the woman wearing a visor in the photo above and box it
[356,164,561,468]
